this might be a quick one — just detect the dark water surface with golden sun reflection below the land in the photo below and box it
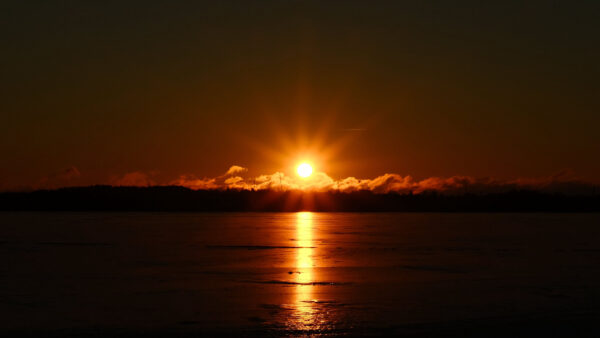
[0,213,600,337]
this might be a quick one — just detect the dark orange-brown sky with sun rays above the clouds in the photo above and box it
[0,0,600,189]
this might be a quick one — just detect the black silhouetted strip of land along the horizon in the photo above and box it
[0,186,600,212]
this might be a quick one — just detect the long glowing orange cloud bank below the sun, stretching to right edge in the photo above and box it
[162,165,600,194]
